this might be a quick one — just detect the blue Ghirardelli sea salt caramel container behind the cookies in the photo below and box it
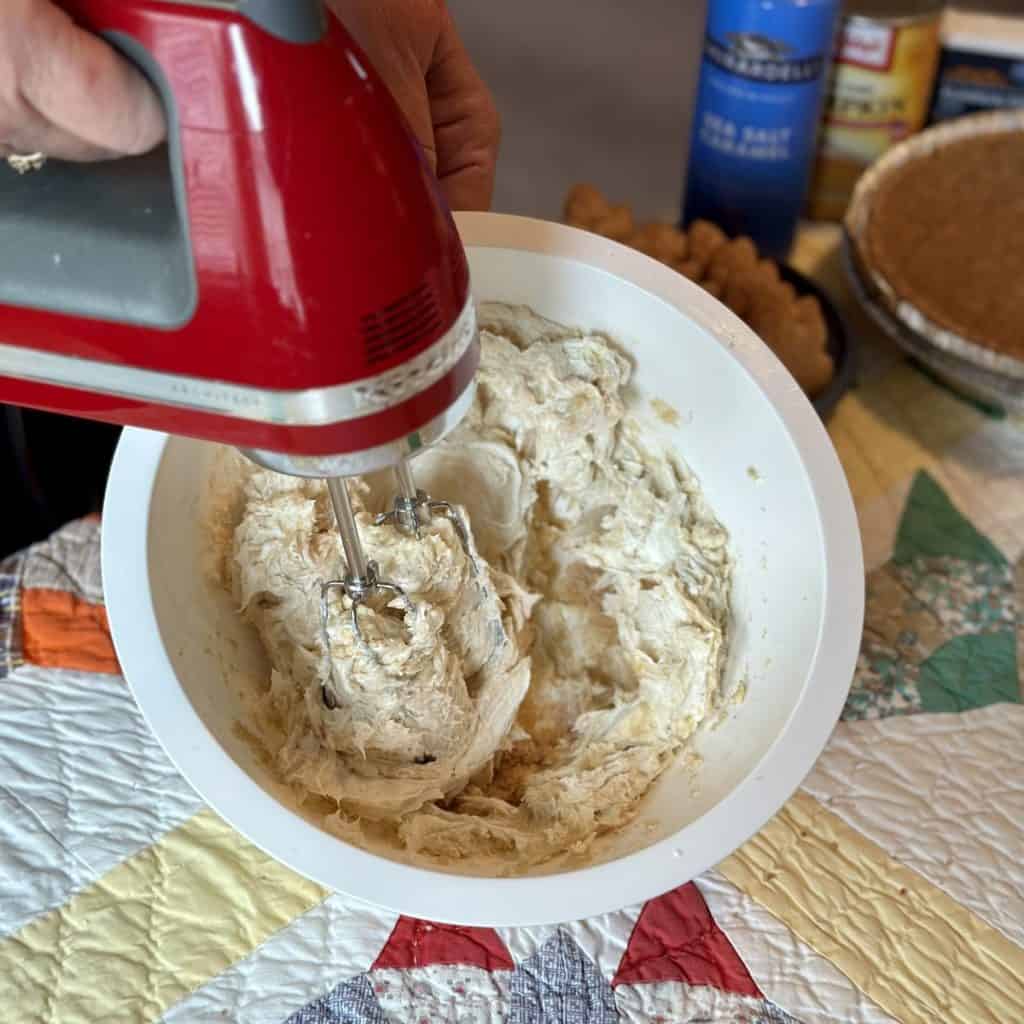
[683,0,840,259]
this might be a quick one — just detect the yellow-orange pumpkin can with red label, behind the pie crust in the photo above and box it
[808,0,944,220]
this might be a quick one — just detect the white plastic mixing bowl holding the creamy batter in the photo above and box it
[103,214,864,926]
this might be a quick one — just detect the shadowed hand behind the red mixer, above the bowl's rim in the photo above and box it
[330,0,501,210]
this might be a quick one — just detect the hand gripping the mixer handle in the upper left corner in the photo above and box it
[0,0,166,160]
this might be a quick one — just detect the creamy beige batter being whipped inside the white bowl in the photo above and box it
[211,304,731,874]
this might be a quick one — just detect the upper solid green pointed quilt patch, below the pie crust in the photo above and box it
[893,470,1007,565]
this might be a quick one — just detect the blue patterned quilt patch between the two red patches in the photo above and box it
[508,932,618,1024]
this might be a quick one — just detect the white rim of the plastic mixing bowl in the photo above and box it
[102,213,864,927]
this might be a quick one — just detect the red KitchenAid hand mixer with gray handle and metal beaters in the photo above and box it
[0,0,479,655]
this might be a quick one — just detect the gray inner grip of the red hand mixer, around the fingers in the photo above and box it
[0,33,198,330]
